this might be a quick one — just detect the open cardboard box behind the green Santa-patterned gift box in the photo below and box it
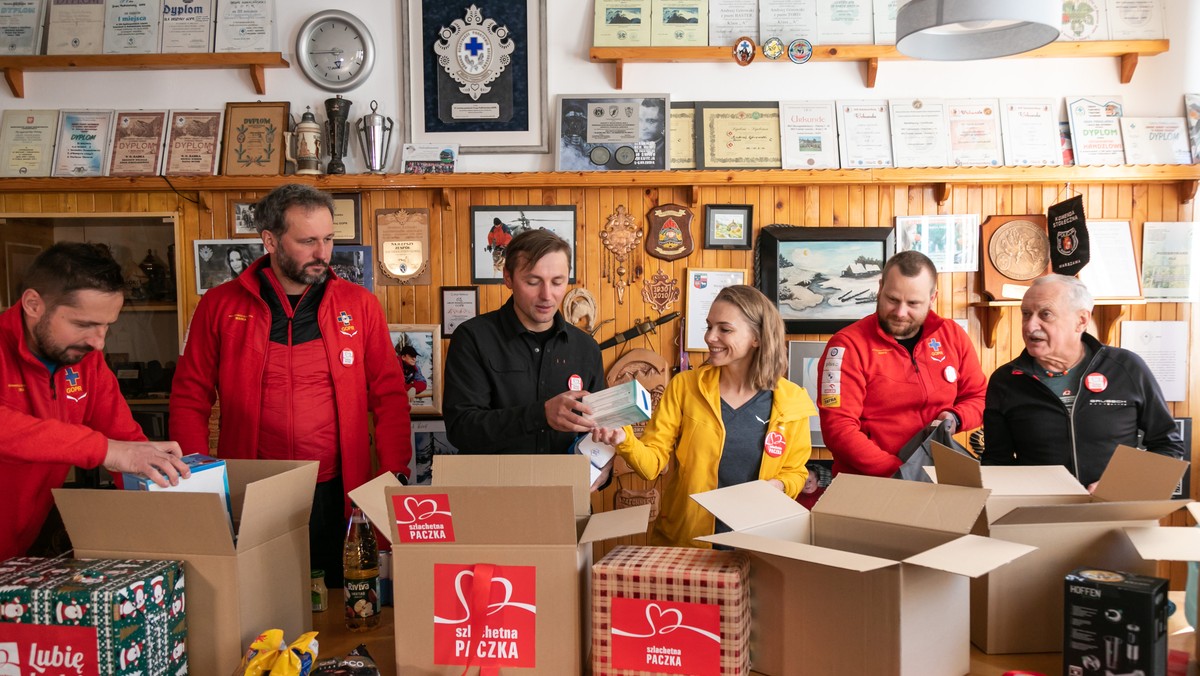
[54,460,317,674]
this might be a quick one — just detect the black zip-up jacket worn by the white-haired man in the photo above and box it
[982,334,1183,486]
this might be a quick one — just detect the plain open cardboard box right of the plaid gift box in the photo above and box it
[692,474,1033,676]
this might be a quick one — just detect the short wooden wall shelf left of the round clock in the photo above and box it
[0,52,288,98]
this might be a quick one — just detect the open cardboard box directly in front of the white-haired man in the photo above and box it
[934,444,1200,653]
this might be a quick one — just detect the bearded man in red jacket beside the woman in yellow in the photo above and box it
[817,251,990,477]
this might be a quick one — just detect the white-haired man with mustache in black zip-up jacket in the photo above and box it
[983,275,1183,490]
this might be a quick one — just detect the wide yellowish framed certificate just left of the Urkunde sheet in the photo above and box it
[696,101,782,169]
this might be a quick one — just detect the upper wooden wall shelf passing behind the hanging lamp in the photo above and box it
[589,40,1170,89]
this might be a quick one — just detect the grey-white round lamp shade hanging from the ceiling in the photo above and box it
[896,0,1062,61]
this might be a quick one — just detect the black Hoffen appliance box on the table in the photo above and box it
[1062,568,1168,675]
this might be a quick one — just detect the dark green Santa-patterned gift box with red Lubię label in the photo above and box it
[0,557,187,676]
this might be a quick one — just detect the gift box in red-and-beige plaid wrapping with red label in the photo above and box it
[592,546,750,676]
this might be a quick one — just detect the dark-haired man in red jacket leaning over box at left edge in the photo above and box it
[0,241,188,561]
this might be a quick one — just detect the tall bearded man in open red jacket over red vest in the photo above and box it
[170,184,413,587]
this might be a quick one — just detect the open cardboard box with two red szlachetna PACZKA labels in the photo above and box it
[350,455,649,676]
